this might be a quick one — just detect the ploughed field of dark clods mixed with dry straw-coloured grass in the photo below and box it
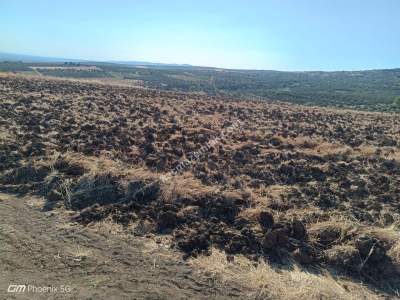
[0,75,400,299]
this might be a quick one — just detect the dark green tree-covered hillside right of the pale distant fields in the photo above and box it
[96,66,400,111]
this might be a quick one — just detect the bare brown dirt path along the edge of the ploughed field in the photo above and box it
[0,194,246,299]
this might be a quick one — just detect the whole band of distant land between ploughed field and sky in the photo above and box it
[0,53,400,111]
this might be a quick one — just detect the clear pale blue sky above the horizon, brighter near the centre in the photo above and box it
[0,0,400,70]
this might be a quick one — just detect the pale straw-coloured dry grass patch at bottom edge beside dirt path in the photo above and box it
[191,249,384,300]
